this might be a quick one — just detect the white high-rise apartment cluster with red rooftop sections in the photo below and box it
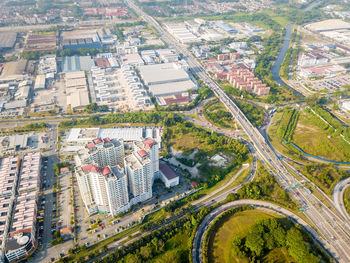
[75,138,159,215]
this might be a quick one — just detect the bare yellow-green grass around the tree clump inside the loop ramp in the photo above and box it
[208,210,293,263]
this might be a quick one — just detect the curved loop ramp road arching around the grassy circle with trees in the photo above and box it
[192,199,331,263]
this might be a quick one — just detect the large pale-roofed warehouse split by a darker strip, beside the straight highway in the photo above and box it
[139,63,197,96]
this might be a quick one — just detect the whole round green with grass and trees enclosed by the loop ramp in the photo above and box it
[203,208,329,263]
